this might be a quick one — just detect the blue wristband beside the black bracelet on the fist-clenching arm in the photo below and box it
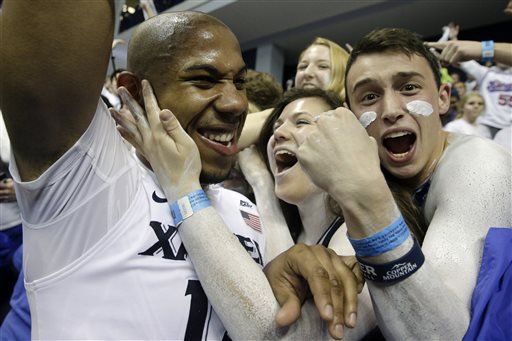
[348,215,409,257]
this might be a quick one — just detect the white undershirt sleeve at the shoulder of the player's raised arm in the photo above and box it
[11,100,137,281]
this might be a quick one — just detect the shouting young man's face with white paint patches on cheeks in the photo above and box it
[347,51,450,187]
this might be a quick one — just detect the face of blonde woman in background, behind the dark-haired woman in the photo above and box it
[295,45,331,89]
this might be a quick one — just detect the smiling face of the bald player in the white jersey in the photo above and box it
[155,26,247,183]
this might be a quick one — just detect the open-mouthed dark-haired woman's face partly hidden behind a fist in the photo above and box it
[267,97,331,205]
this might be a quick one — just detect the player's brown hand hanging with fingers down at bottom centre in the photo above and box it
[264,244,364,339]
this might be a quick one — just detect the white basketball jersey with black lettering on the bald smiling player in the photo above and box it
[11,101,265,340]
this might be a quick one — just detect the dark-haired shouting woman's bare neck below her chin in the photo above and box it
[297,193,336,245]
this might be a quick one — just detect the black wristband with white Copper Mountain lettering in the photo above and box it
[356,238,425,283]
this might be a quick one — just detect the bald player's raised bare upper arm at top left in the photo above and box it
[0,0,114,181]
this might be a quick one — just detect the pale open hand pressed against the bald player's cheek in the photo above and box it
[111,80,201,202]
